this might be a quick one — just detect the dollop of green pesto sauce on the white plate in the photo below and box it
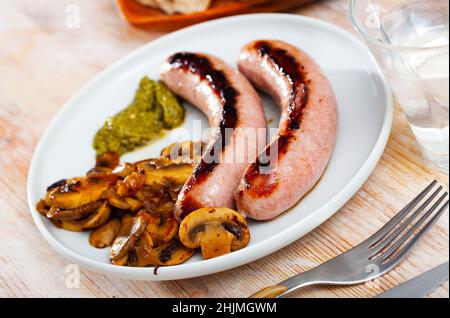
[94,77,184,155]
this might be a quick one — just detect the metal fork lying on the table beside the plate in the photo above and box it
[251,180,449,298]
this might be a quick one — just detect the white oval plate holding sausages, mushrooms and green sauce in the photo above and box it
[28,14,393,280]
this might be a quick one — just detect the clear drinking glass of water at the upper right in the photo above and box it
[350,0,449,174]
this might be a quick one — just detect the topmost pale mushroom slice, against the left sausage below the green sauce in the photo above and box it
[161,141,206,165]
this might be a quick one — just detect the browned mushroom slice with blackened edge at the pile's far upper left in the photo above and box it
[45,173,117,210]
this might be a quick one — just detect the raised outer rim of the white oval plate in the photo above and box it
[27,13,394,281]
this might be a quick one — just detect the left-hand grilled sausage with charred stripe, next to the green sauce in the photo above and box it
[161,53,267,220]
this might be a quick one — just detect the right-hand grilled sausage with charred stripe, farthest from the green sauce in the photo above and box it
[236,41,338,220]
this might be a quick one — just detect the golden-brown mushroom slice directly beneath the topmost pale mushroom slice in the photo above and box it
[138,158,193,187]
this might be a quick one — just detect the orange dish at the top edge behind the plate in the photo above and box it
[117,0,311,25]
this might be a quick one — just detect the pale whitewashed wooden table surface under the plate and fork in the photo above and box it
[0,0,449,297]
